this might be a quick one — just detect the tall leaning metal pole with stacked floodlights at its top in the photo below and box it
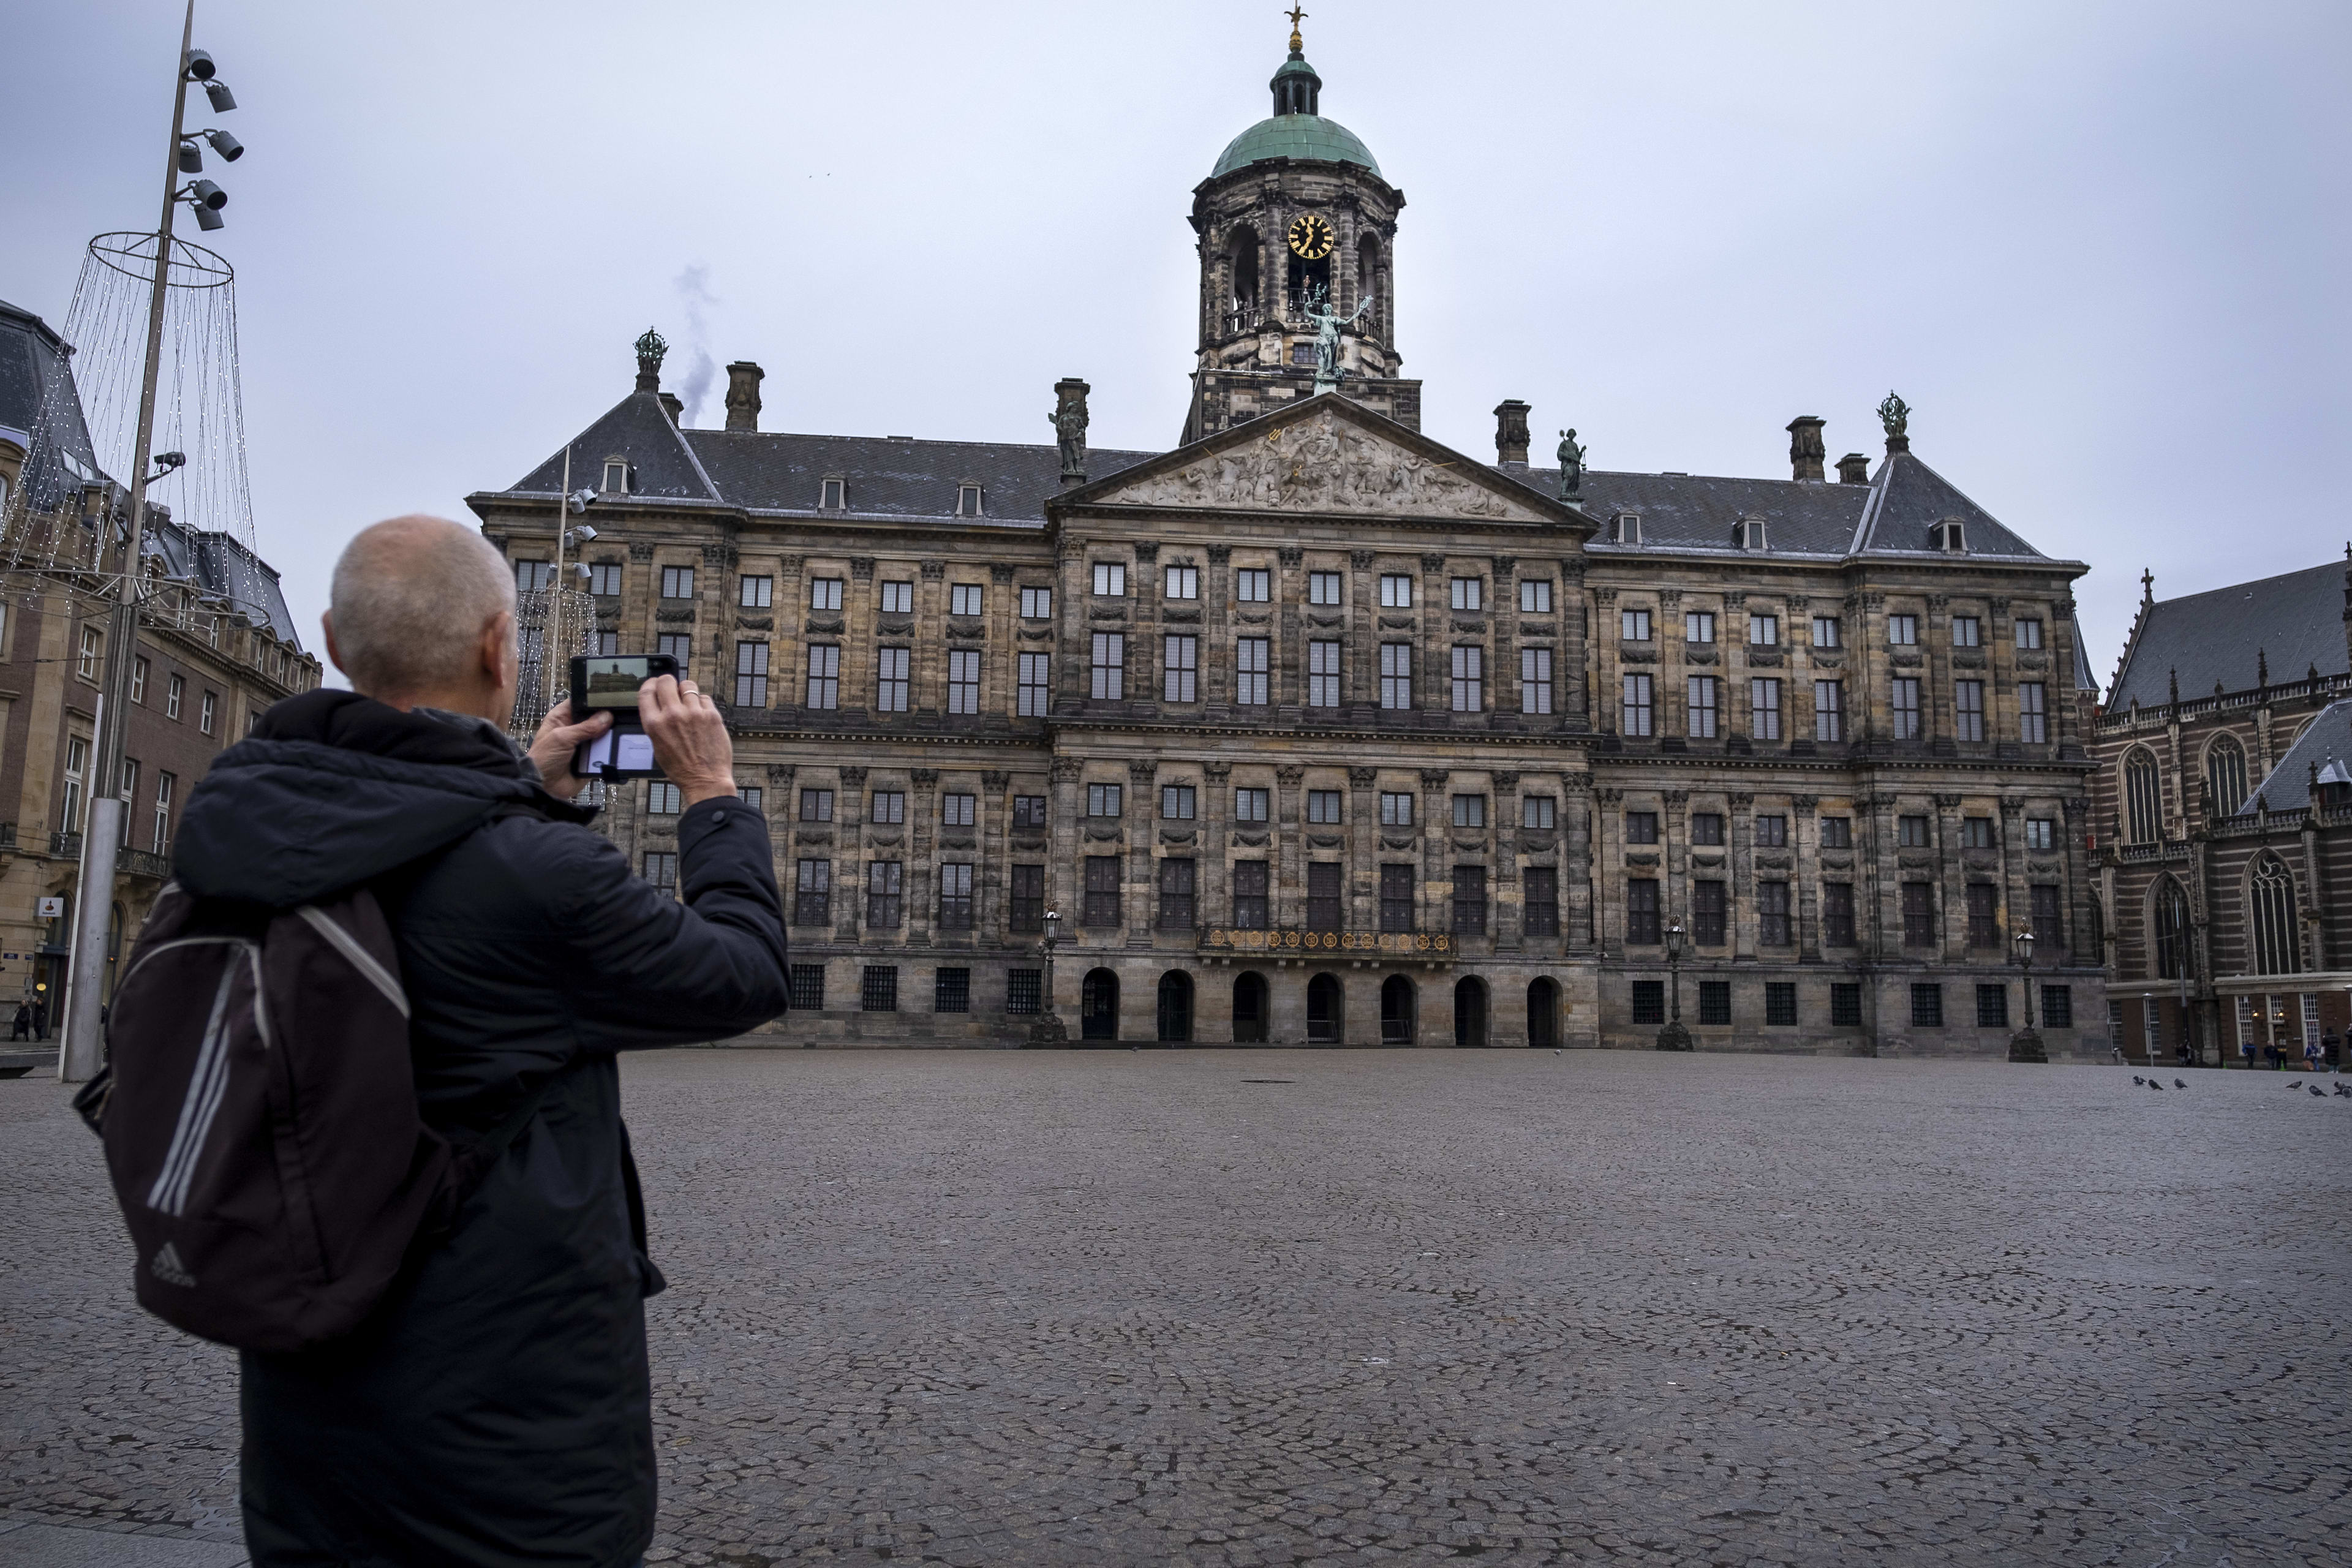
[56,0,244,1084]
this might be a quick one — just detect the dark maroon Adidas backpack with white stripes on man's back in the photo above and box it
[75,851,552,1352]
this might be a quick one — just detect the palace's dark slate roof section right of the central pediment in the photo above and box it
[1506,451,2046,559]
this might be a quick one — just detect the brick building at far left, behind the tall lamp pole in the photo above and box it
[0,301,320,1035]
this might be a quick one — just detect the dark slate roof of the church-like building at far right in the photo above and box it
[2108,562,2352,710]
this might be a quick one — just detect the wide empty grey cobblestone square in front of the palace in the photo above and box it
[0,1049,2352,1568]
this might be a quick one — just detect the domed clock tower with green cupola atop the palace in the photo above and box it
[1183,19,1420,442]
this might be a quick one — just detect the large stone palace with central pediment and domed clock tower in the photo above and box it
[468,33,2108,1055]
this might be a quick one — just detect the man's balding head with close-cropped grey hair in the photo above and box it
[327,515,515,701]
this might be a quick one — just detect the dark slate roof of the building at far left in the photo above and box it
[0,301,301,649]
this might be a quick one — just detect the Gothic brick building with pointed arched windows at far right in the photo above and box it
[2094,552,2352,1063]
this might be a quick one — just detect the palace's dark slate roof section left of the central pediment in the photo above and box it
[508,393,1159,527]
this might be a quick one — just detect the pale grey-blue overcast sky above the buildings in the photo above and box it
[0,0,2352,679]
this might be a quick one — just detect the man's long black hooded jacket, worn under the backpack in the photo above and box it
[174,691,786,1568]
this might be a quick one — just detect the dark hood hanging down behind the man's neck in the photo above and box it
[172,691,595,910]
